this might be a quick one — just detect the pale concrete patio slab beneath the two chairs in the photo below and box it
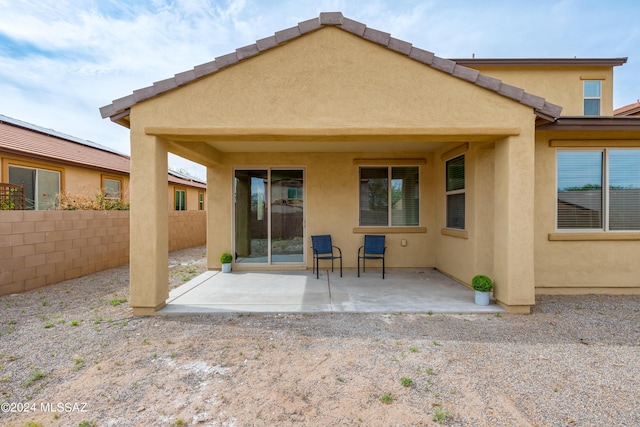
[158,269,506,314]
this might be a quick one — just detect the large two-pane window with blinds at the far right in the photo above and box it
[557,149,640,231]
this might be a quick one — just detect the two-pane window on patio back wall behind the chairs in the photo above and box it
[360,166,420,227]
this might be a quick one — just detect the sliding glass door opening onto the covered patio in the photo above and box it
[234,168,304,264]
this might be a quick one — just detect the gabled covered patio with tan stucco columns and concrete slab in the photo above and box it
[101,12,560,315]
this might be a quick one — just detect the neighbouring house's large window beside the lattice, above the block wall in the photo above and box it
[9,166,60,210]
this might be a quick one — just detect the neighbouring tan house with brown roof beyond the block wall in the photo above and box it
[0,115,206,210]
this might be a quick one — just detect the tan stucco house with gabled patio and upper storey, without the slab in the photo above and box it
[100,12,640,314]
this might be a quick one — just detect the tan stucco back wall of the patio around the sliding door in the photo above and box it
[207,153,436,268]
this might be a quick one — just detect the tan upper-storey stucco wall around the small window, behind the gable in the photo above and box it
[473,66,613,116]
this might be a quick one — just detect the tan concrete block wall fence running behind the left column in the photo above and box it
[0,211,206,296]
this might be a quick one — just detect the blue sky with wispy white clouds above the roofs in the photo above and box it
[0,0,640,179]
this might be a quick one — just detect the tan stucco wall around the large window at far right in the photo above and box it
[535,132,640,294]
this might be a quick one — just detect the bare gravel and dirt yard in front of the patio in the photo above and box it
[0,247,640,427]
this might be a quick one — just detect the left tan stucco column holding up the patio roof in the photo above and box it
[129,135,169,316]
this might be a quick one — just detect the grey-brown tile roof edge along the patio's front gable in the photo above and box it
[100,12,562,121]
